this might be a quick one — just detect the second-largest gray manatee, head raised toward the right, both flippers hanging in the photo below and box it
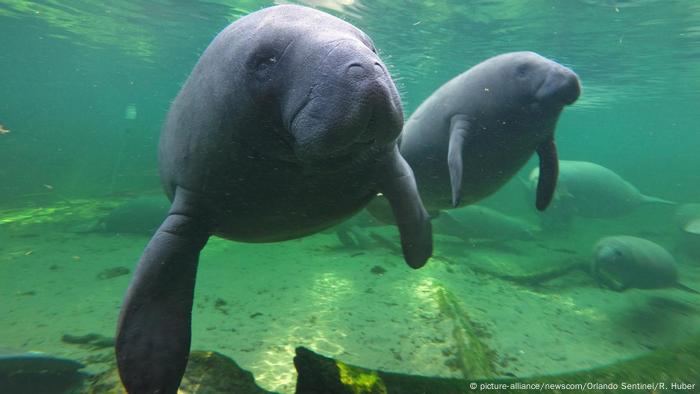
[400,52,581,214]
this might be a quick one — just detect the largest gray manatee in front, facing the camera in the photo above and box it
[116,5,432,393]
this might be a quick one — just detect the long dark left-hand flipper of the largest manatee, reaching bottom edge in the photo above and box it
[116,188,211,394]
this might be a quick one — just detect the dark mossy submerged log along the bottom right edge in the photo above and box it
[294,335,700,394]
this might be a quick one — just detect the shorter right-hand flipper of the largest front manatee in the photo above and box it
[379,147,433,268]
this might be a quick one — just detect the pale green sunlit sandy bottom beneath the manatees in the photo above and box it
[0,199,700,393]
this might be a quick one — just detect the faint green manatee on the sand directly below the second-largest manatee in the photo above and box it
[433,205,536,240]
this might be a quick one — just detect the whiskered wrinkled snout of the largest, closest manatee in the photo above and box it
[292,40,403,161]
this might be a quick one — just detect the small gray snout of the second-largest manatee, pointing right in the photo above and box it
[535,62,581,106]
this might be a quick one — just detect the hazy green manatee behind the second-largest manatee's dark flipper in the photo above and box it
[529,160,675,218]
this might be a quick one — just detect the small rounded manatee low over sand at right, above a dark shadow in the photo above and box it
[591,235,700,294]
